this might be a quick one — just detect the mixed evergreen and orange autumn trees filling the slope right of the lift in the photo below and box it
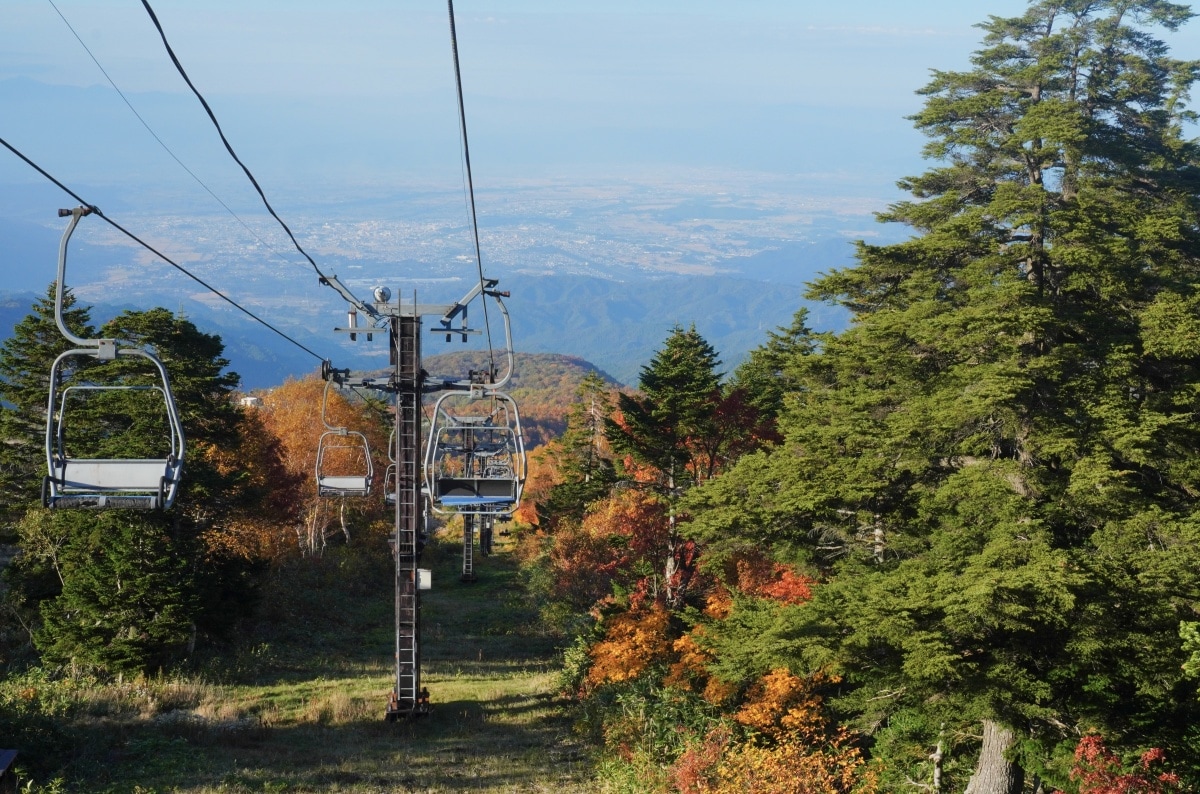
[524,1,1200,794]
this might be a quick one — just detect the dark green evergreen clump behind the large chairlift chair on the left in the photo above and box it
[0,299,265,673]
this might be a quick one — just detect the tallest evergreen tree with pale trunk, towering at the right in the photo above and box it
[688,0,1200,794]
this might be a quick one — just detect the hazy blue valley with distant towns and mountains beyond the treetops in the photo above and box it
[0,174,883,387]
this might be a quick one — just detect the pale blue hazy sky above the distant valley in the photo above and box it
[0,0,1200,202]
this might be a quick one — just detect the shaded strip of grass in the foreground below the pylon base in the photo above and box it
[58,694,592,794]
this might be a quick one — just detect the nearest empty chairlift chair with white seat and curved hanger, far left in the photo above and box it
[42,207,185,510]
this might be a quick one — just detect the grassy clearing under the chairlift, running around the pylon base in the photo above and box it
[39,532,595,793]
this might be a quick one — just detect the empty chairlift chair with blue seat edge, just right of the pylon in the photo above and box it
[425,390,526,516]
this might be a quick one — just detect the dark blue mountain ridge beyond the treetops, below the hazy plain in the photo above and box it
[0,276,845,389]
